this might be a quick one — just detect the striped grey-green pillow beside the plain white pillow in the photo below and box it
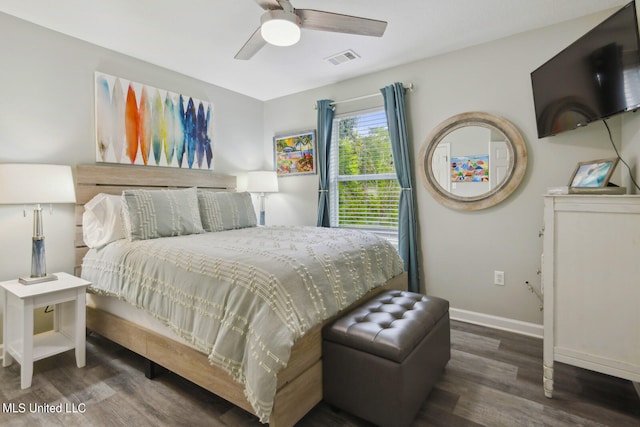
[122,187,204,240]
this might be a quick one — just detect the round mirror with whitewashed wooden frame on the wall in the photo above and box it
[418,112,527,211]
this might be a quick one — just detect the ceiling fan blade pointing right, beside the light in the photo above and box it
[295,9,387,37]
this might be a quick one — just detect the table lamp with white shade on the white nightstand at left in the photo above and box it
[0,163,76,285]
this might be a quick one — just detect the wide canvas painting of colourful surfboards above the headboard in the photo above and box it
[95,72,213,169]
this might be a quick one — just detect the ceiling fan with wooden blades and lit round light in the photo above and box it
[235,0,387,60]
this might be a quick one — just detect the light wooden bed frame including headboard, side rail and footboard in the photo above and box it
[75,165,407,427]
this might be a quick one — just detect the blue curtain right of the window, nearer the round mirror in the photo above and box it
[380,83,420,292]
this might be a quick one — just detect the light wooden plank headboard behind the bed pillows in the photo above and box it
[74,164,236,275]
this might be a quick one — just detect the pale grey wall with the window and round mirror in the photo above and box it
[264,8,640,324]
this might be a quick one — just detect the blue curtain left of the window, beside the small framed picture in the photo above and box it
[317,99,334,227]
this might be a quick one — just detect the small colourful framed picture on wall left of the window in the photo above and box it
[273,130,316,176]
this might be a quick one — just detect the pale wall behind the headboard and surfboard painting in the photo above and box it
[0,13,264,334]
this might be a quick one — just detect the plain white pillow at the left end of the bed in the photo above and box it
[82,193,125,248]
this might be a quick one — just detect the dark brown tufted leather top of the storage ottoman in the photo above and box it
[322,291,449,362]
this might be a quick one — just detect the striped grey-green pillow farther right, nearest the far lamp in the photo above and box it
[198,190,257,231]
